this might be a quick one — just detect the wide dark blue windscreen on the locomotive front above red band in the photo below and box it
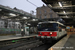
[38,23,58,31]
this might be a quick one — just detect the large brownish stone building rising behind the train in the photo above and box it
[36,5,58,19]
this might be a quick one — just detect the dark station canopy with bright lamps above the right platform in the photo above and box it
[42,0,75,26]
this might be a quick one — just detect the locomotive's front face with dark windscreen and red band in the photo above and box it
[38,23,58,42]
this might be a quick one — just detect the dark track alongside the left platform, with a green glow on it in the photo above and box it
[0,37,36,48]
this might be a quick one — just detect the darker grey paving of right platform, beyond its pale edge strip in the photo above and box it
[62,34,75,50]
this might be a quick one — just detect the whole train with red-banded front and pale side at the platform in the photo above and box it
[37,21,67,42]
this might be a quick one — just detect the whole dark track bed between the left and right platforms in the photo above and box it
[0,36,67,50]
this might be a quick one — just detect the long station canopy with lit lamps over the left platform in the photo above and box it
[0,5,41,23]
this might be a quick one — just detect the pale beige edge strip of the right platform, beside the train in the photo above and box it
[48,36,70,50]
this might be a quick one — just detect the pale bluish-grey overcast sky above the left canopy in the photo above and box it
[0,0,45,13]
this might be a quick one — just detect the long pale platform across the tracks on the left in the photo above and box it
[0,34,37,41]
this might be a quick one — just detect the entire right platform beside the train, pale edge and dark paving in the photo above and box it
[48,34,75,50]
